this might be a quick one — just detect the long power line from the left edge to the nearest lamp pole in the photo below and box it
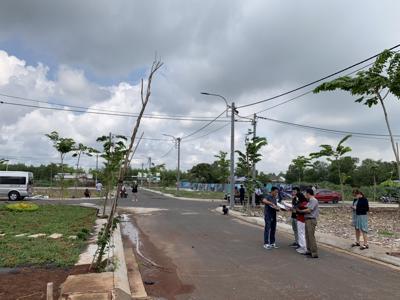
[0,100,244,123]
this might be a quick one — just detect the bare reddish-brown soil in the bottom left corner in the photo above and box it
[0,265,89,300]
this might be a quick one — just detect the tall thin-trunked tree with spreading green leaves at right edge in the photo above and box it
[314,50,400,183]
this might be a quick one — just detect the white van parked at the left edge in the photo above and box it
[0,171,33,201]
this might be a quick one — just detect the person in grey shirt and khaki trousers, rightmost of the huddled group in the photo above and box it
[297,188,319,258]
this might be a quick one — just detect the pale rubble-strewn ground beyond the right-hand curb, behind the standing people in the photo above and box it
[236,206,400,253]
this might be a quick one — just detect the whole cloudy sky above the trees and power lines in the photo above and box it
[0,0,400,172]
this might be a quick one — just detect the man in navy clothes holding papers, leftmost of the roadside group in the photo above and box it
[262,186,279,250]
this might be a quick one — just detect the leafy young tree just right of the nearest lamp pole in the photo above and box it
[236,137,267,209]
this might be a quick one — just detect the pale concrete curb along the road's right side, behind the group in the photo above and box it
[214,207,400,270]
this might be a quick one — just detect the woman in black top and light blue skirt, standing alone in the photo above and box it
[351,190,369,250]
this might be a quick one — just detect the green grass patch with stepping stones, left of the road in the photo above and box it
[0,205,96,267]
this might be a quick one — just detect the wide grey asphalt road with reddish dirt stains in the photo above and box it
[114,192,400,300]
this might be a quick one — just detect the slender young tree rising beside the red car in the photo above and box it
[310,135,351,201]
